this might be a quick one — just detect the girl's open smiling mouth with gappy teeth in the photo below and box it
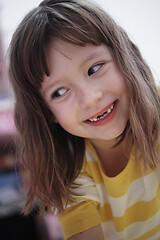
[86,100,118,122]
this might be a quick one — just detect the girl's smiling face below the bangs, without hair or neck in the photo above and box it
[41,39,129,144]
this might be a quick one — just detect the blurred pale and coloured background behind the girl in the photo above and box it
[0,0,160,240]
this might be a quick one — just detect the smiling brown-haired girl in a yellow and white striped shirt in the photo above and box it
[9,0,160,240]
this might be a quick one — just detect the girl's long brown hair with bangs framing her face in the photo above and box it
[9,0,160,213]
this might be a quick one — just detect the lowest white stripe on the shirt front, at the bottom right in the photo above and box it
[101,211,160,240]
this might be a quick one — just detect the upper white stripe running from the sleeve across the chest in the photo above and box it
[71,169,160,217]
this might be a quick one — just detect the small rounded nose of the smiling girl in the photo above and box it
[80,85,103,108]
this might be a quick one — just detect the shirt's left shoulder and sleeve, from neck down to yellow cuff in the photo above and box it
[58,143,101,239]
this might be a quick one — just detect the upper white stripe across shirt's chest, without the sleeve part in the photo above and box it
[96,169,160,217]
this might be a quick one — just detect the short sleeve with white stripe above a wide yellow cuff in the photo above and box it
[58,172,101,239]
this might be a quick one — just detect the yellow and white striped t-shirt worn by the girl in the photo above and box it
[59,141,160,240]
